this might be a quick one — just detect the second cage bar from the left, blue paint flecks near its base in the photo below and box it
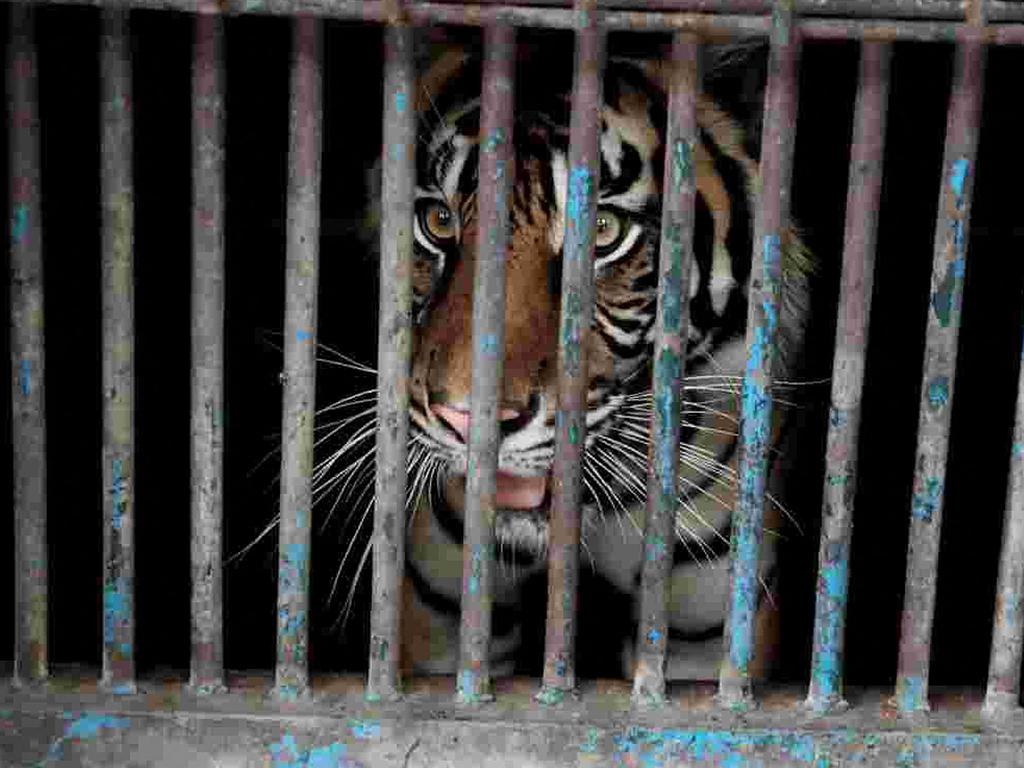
[100,9,135,693]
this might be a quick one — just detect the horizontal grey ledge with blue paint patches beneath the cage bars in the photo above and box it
[0,679,1011,768]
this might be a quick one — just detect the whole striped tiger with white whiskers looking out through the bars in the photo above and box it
[316,39,810,679]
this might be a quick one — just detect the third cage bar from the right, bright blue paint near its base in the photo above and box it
[807,42,892,713]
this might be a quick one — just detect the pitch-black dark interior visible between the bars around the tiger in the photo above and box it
[0,8,1024,684]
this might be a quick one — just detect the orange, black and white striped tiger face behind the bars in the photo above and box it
[399,53,782,556]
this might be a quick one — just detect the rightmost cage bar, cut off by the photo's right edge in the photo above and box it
[983,315,1024,717]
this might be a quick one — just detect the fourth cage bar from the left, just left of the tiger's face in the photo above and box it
[274,15,322,699]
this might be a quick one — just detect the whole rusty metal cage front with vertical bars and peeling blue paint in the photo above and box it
[6,0,1024,766]
